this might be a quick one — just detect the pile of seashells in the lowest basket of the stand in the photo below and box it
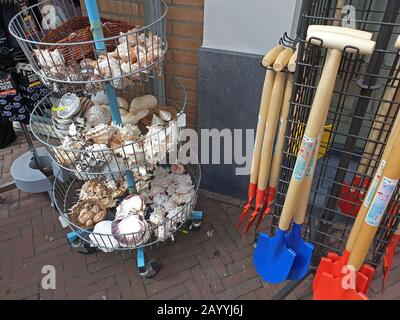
[80,163,195,252]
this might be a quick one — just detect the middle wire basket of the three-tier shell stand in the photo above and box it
[30,76,186,180]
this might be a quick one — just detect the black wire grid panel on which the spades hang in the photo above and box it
[271,1,399,267]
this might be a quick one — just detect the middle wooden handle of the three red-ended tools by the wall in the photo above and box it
[258,72,286,190]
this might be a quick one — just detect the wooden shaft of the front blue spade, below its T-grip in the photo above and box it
[279,49,342,231]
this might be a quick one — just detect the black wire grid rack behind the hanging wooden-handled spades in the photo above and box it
[271,0,400,299]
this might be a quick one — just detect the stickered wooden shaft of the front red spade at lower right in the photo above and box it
[348,134,400,271]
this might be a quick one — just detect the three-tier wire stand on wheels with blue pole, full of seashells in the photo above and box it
[9,0,203,277]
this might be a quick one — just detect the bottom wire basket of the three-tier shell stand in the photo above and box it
[54,164,201,252]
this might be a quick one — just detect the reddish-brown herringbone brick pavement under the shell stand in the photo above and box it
[0,138,400,300]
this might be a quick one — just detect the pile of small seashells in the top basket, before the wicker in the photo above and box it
[34,28,164,94]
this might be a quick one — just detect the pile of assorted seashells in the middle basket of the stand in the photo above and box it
[52,91,178,173]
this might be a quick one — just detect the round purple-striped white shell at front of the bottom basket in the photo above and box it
[111,216,146,247]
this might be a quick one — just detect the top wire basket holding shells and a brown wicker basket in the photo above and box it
[9,0,167,93]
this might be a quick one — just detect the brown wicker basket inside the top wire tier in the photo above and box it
[39,17,137,64]
